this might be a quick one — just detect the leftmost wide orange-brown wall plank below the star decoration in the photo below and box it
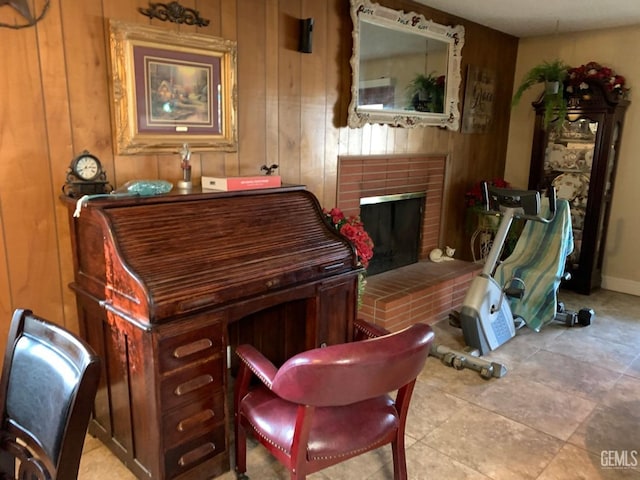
[0,19,63,326]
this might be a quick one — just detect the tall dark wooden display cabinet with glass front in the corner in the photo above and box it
[529,80,629,294]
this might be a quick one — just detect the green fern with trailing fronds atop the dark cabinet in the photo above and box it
[511,59,570,128]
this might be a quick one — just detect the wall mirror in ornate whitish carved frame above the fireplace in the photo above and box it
[349,0,464,130]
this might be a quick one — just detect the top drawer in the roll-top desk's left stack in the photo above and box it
[158,321,224,373]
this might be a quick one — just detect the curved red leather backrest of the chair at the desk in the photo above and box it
[271,323,434,406]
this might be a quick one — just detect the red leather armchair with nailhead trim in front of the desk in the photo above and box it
[234,321,433,480]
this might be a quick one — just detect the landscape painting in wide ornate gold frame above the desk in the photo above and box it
[109,20,238,155]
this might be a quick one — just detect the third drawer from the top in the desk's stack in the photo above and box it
[162,389,225,448]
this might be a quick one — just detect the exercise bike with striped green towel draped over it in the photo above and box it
[432,182,595,378]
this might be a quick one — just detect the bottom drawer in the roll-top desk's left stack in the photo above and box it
[164,425,226,478]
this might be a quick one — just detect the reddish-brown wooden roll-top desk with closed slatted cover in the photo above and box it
[64,187,360,479]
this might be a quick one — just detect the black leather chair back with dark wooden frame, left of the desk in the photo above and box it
[0,310,100,480]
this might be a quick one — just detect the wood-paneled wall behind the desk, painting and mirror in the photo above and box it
[0,0,527,348]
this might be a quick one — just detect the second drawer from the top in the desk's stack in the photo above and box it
[160,355,224,413]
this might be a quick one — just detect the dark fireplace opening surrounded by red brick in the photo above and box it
[360,192,426,275]
